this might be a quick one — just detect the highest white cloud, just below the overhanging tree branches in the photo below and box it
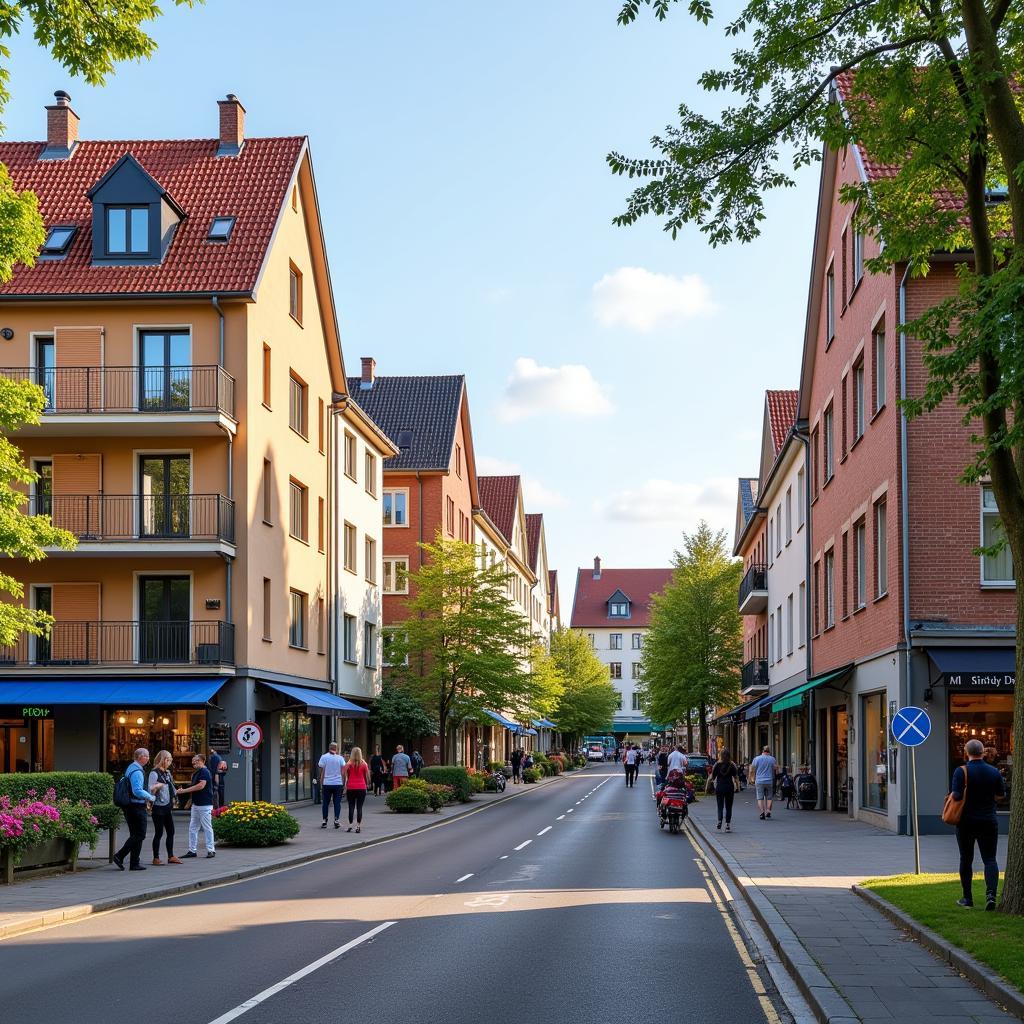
[594,266,717,334]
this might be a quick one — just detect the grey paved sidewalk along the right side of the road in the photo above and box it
[690,787,1017,1024]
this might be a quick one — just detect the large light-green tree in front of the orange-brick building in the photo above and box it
[388,535,532,753]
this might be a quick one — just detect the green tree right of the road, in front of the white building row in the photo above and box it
[639,520,743,751]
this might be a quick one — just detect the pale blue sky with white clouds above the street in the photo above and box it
[5,0,817,613]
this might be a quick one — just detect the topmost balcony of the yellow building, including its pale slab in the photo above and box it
[0,366,238,435]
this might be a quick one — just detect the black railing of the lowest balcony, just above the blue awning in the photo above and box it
[0,620,234,668]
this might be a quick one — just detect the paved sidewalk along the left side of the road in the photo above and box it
[0,771,582,939]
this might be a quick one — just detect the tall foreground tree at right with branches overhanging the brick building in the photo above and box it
[608,0,1024,913]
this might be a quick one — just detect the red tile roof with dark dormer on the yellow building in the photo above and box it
[0,137,305,296]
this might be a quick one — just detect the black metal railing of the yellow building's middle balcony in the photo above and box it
[29,495,234,544]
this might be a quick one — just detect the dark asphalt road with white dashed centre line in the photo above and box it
[0,765,784,1024]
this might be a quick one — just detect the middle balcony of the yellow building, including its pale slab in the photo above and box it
[29,495,234,555]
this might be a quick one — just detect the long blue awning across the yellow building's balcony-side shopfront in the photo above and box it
[0,676,227,708]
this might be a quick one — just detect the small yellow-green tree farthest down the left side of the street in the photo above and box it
[549,629,618,744]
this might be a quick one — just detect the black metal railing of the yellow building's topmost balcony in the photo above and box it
[0,366,234,418]
